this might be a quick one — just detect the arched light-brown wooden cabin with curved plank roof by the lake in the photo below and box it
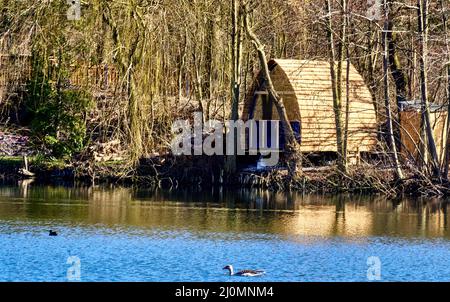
[242,59,378,162]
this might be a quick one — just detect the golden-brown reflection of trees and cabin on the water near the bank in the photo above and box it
[0,183,450,239]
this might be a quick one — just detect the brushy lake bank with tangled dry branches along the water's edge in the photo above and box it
[0,157,442,198]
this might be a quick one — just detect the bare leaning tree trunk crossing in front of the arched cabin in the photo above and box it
[242,5,301,177]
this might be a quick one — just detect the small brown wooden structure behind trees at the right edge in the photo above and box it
[399,101,447,160]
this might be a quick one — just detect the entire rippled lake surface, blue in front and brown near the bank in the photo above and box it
[0,179,450,281]
